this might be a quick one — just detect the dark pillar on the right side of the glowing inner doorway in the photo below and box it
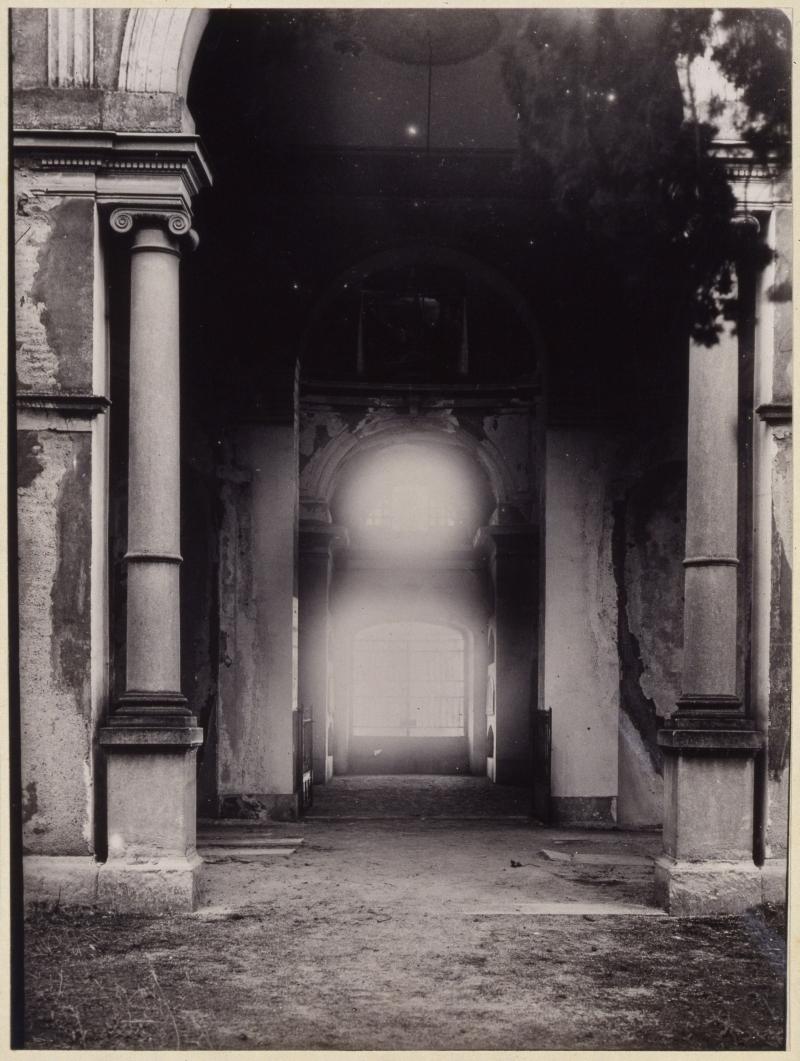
[476,523,538,785]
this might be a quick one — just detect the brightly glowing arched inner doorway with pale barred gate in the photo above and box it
[322,435,497,776]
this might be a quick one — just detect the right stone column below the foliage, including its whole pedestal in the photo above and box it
[656,305,762,915]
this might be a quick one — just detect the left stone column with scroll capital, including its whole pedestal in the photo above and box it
[99,210,202,910]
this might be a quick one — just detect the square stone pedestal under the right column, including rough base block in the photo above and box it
[656,723,763,917]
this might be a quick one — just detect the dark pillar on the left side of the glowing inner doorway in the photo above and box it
[298,521,346,784]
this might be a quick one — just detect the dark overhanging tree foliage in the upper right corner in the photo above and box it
[503,8,790,345]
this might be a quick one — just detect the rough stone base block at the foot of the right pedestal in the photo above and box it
[656,855,764,918]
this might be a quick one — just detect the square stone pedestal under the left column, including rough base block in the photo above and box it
[98,726,203,914]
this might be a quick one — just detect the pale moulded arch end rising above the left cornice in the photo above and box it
[118,7,210,99]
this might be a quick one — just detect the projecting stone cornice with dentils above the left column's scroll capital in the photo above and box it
[13,129,212,196]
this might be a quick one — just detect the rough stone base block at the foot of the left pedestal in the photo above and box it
[98,855,203,915]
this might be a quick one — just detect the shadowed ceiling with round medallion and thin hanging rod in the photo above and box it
[190,11,517,151]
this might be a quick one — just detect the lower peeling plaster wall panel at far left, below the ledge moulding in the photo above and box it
[18,430,93,855]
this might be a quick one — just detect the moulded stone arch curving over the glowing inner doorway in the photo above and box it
[300,411,518,506]
